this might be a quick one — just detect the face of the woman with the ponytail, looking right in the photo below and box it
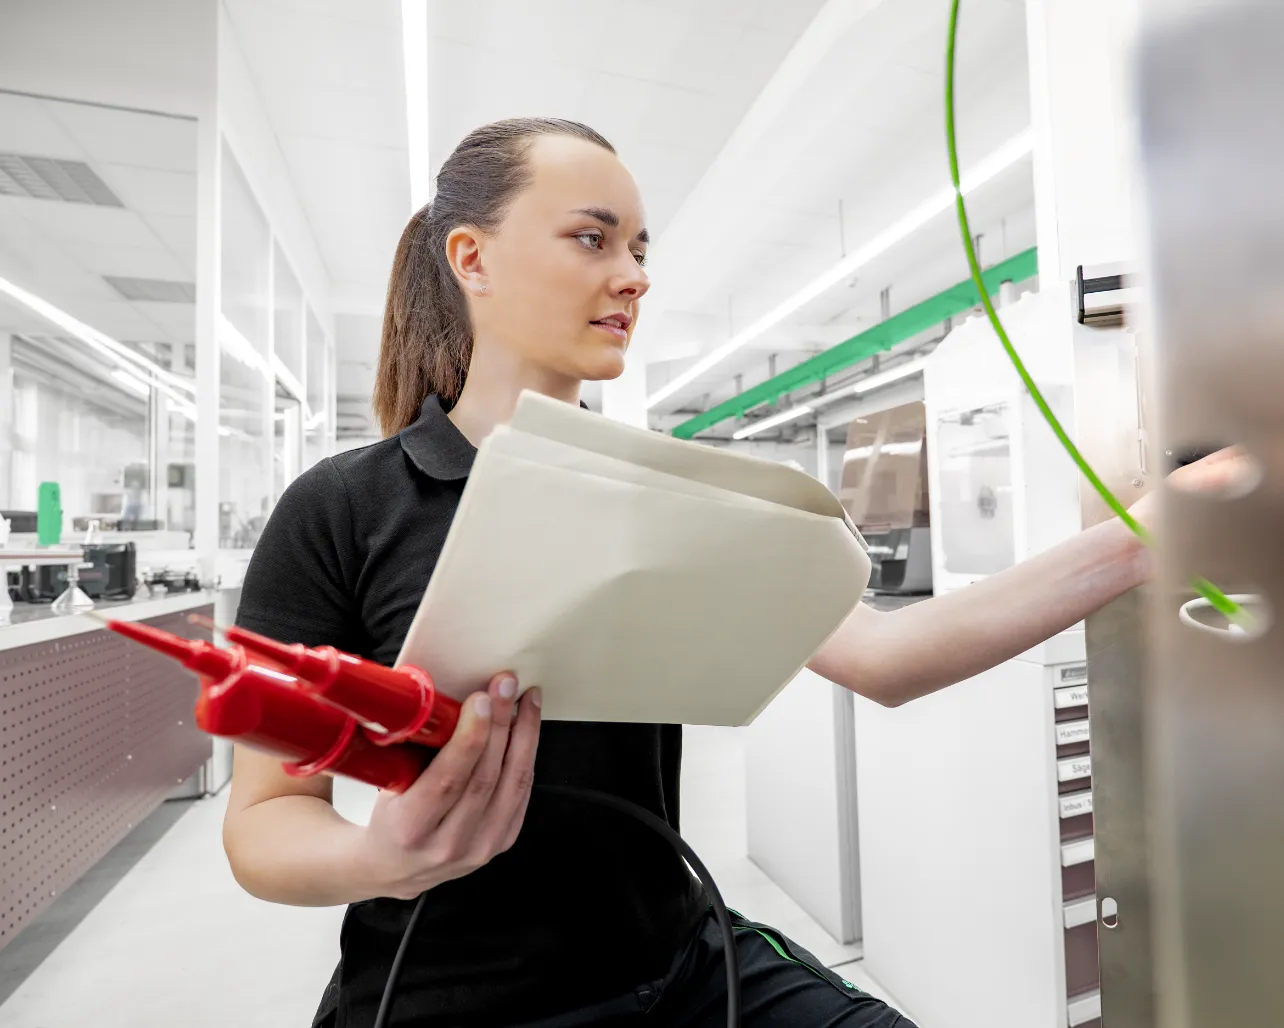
[455,136,650,381]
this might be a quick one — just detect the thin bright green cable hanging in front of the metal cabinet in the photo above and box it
[945,0,1248,624]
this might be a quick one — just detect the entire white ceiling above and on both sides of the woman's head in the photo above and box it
[223,0,1034,427]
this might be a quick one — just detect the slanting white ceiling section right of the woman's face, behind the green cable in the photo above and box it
[638,0,1034,420]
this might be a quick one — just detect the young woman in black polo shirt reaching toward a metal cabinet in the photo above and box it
[223,119,1236,1028]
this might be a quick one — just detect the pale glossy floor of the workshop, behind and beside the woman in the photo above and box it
[0,729,895,1028]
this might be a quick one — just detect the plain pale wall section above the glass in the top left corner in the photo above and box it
[0,0,217,117]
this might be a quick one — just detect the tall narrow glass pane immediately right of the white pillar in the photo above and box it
[218,145,275,549]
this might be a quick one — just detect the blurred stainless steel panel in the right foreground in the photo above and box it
[1140,3,1284,1028]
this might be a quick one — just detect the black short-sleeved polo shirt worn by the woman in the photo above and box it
[236,397,704,1028]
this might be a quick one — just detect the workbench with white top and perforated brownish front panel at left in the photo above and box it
[0,592,214,950]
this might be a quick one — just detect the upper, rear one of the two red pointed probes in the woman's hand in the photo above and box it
[225,626,460,750]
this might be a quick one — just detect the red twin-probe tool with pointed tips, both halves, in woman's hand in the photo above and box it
[101,619,460,792]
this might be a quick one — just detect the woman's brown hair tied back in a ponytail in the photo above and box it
[374,118,615,435]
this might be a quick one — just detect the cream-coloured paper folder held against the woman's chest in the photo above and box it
[397,393,869,725]
